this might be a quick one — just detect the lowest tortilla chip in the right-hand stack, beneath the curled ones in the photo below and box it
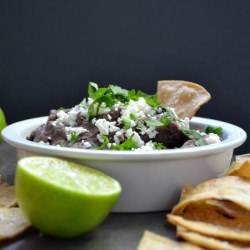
[177,227,250,250]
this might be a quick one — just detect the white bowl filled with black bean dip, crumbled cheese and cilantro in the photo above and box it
[2,83,246,212]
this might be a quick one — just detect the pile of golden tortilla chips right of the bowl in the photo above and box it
[138,154,250,250]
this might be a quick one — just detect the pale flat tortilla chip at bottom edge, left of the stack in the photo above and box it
[137,231,202,250]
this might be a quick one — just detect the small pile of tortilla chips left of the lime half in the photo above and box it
[0,178,31,241]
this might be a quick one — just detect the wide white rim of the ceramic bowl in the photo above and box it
[2,116,247,161]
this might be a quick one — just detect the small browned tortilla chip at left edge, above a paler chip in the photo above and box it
[0,185,17,207]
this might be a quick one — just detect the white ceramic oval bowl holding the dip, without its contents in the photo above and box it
[2,117,247,212]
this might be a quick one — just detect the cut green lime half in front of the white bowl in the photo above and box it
[15,156,121,238]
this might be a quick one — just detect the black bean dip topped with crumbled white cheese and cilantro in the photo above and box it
[27,83,221,150]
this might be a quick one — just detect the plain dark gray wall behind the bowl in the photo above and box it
[0,0,250,153]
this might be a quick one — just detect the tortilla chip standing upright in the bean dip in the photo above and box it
[157,80,211,119]
